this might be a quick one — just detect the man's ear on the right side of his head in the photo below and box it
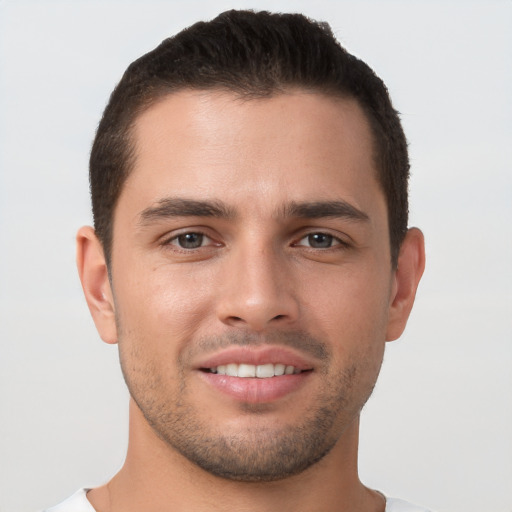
[386,228,425,341]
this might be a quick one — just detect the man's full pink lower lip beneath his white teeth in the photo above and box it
[201,372,312,404]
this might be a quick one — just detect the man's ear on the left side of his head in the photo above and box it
[76,226,117,343]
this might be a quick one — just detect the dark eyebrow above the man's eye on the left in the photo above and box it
[140,197,235,224]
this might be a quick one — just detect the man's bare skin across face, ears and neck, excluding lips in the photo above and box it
[77,90,424,512]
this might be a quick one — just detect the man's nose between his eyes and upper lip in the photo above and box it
[217,244,299,332]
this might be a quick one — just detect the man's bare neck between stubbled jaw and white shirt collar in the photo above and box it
[87,401,384,512]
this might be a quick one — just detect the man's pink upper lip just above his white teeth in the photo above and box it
[197,345,313,370]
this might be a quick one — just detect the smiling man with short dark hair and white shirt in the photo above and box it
[45,11,425,512]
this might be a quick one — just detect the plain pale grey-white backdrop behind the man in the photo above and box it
[0,0,512,512]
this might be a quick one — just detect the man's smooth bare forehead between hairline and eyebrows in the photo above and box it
[120,90,378,220]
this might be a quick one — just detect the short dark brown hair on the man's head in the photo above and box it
[89,10,409,265]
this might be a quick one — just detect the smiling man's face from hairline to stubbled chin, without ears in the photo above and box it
[104,91,396,481]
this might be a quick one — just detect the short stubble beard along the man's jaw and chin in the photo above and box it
[121,330,375,482]
